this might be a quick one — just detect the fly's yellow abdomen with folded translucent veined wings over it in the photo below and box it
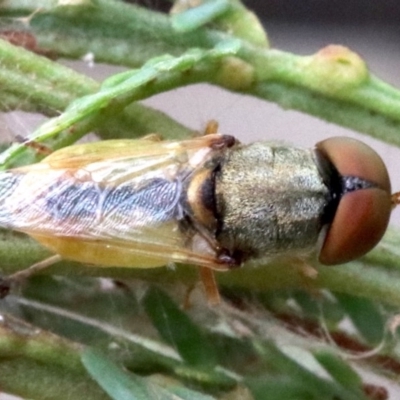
[0,135,233,268]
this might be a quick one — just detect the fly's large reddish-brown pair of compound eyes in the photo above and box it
[316,137,391,265]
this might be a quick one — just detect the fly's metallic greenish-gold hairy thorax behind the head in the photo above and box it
[216,143,330,260]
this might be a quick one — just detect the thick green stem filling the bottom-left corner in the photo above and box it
[0,314,109,400]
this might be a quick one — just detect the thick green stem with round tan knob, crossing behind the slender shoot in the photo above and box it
[1,0,400,145]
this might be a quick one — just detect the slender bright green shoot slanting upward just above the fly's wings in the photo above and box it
[0,41,238,168]
